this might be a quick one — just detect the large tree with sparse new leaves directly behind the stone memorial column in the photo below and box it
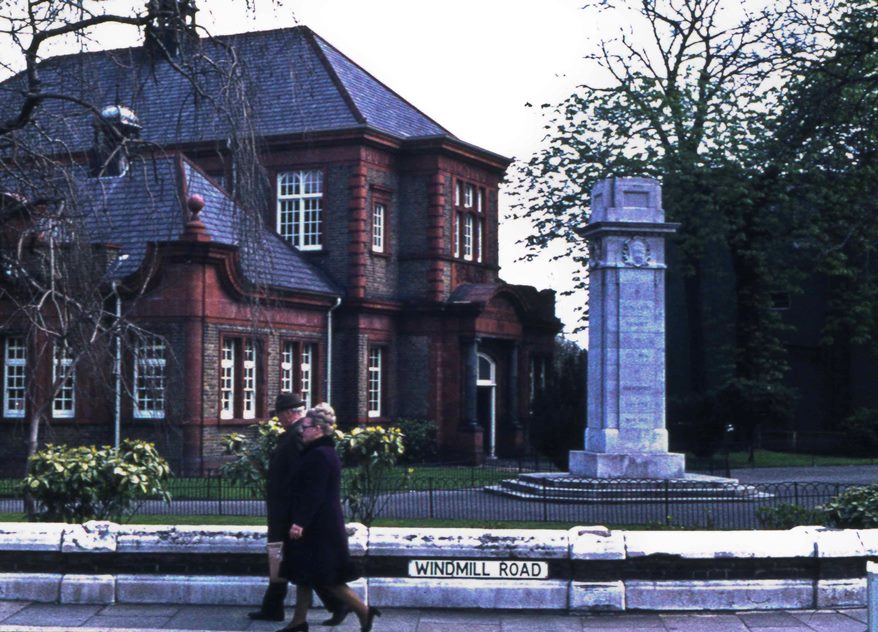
[516,0,844,446]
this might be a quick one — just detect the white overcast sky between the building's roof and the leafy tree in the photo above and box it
[8,0,600,343]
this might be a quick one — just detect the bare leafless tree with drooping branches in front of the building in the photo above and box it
[0,0,284,496]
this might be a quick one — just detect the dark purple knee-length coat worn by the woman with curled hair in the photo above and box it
[281,436,355,586]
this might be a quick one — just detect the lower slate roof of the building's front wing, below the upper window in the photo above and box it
[63,157,339,295]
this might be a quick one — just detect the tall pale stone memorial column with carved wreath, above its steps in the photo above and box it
[570,178,685,479]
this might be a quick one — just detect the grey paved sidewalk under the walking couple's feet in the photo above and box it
[0,601,867,632]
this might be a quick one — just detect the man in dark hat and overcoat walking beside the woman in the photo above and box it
[247,393,350,625]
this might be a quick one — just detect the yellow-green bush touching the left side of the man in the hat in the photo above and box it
[220,417,284,498]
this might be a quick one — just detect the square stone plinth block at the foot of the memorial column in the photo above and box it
[570,450,686,479]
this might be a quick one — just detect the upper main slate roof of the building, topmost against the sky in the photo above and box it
[0,26,454,154]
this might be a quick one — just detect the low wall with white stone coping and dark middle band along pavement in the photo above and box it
[0,522,878,611]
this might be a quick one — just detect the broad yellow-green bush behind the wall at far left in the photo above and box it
[22,439,171,523]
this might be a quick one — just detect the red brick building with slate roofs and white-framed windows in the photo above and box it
[0,22,560,472]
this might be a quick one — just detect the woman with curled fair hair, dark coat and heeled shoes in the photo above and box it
[278,404,381,632]
